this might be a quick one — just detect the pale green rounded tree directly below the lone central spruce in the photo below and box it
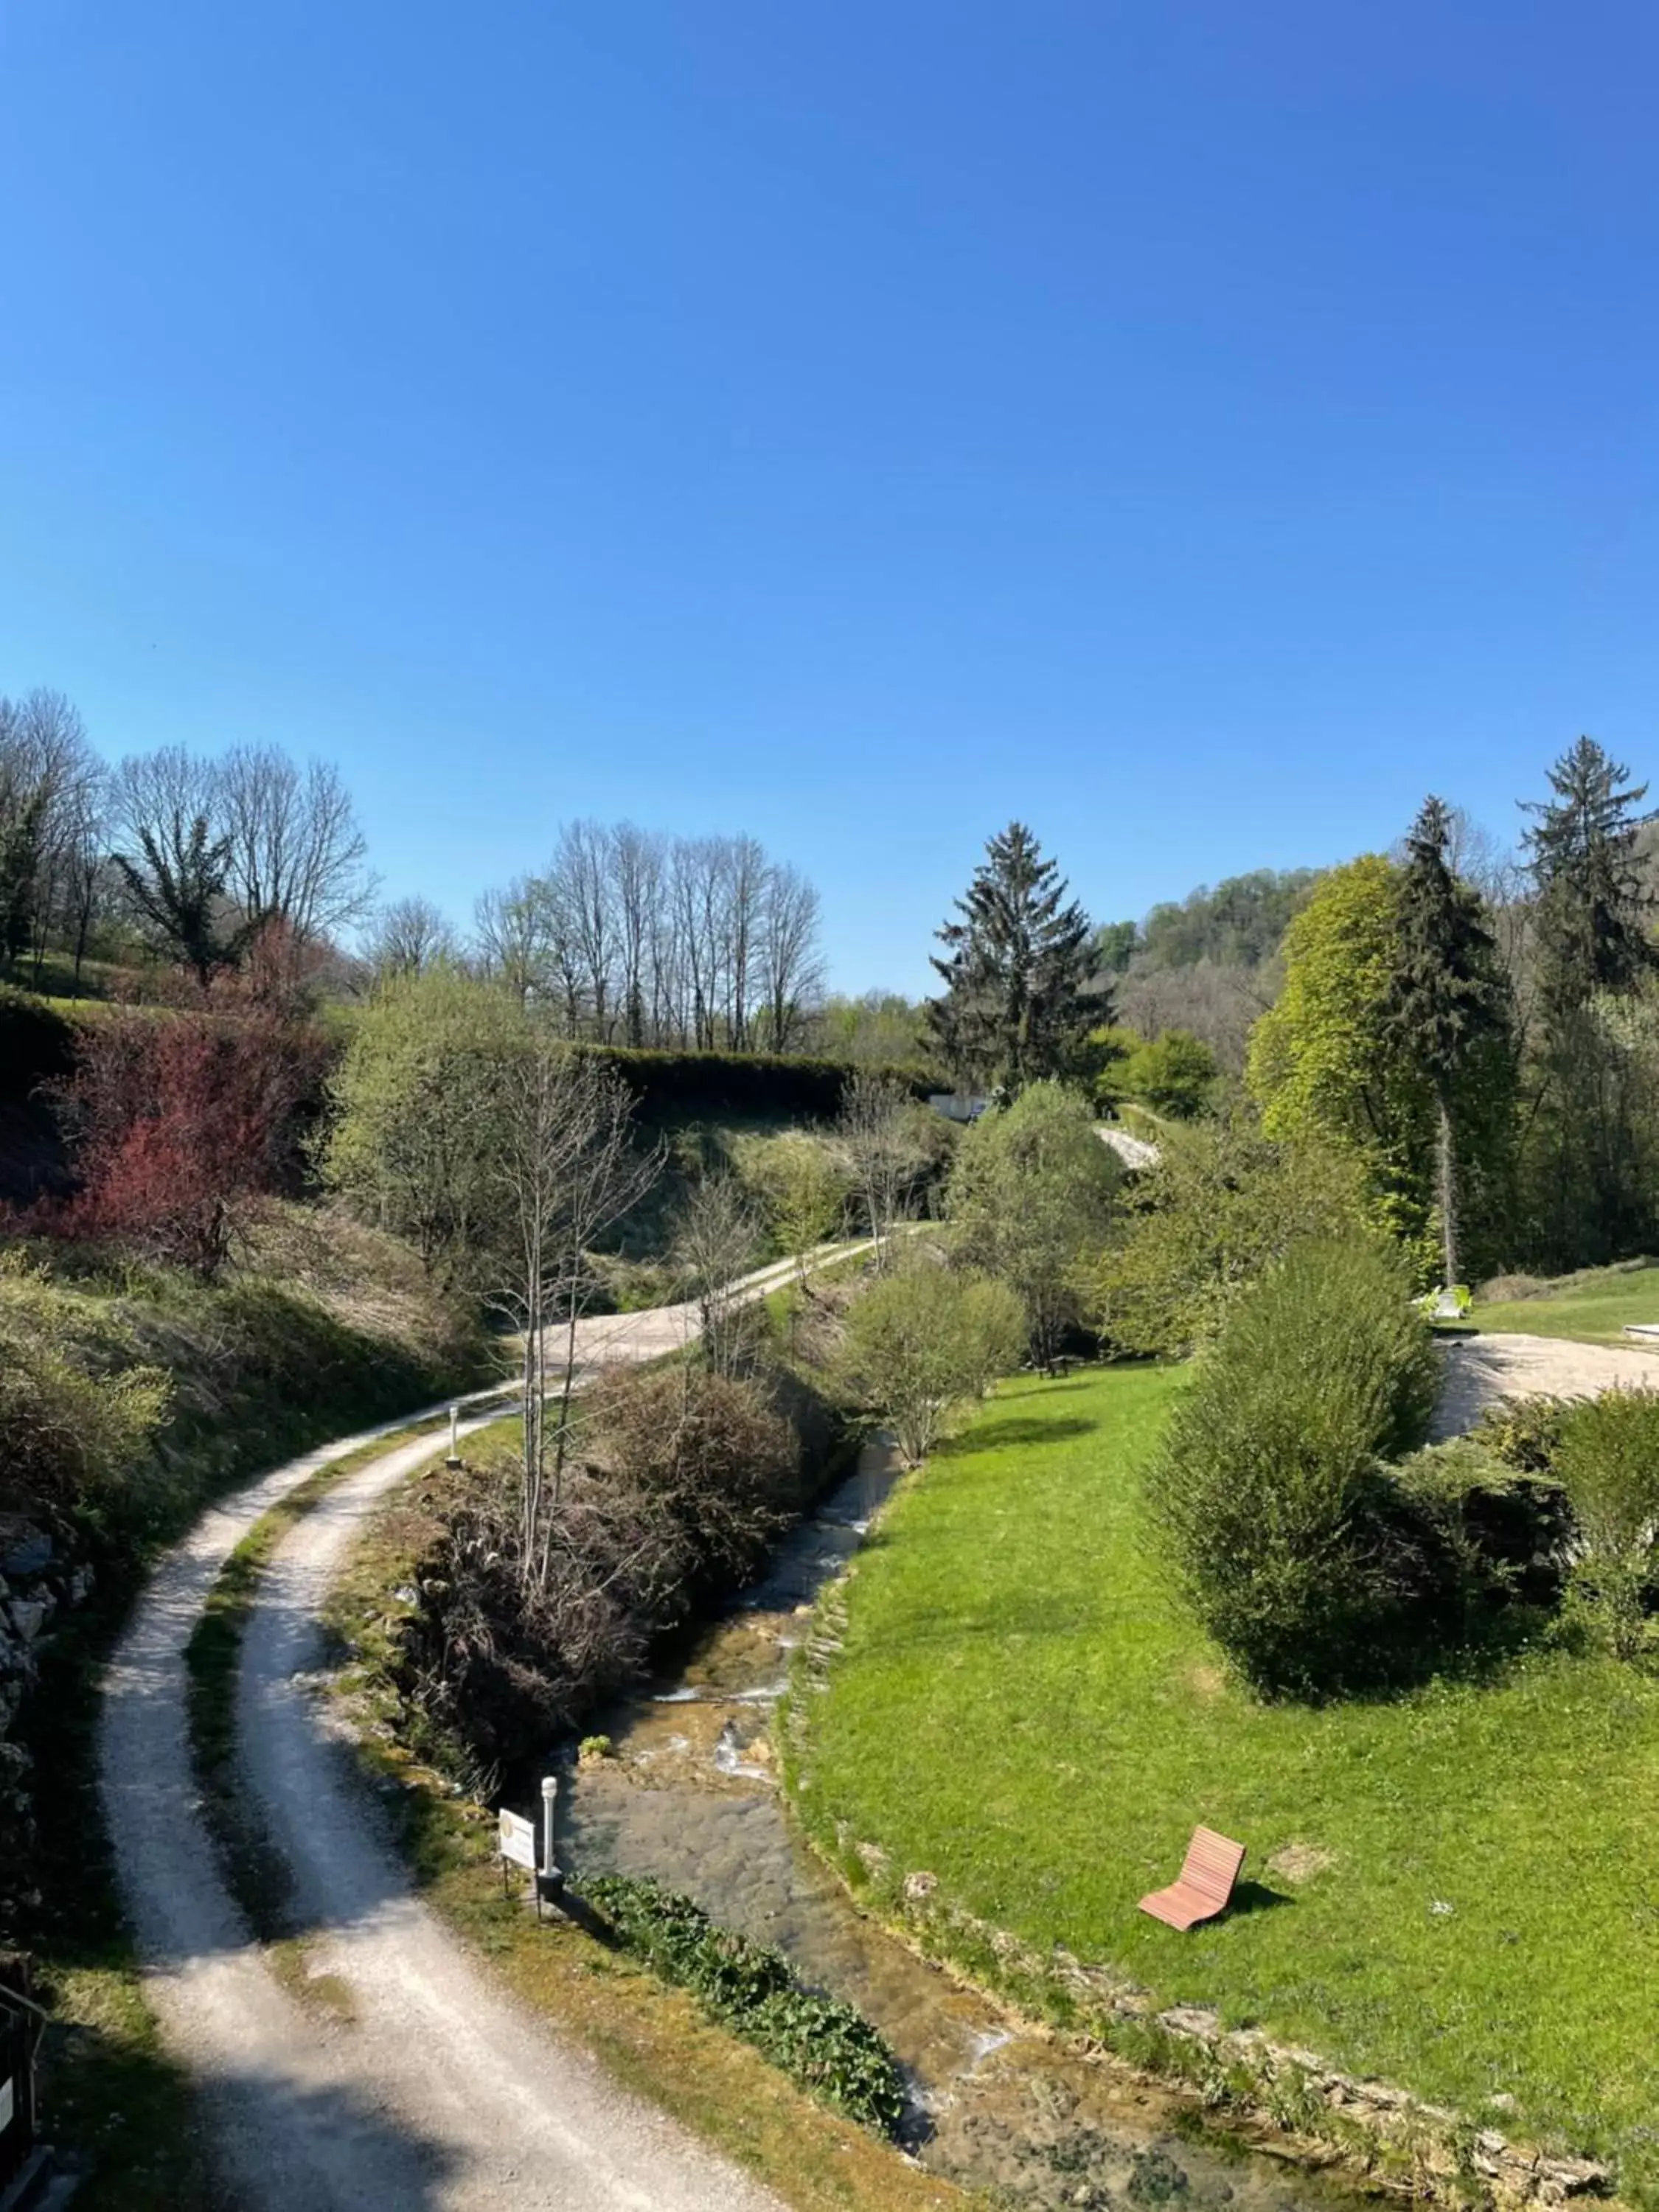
[947,1082,1124,1367]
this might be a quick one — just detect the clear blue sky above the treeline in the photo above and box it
[0,0,1659,989]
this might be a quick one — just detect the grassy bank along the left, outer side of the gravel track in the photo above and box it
[20,1210,484,2212]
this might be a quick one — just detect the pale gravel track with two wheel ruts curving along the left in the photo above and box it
[100,1248,852,2212]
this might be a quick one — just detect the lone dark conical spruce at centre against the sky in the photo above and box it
[927,823,1110,1095]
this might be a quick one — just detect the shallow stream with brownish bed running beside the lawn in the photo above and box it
[560,1444,1356,2212]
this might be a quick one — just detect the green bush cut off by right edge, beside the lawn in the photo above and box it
[1555,1389,1659,1659]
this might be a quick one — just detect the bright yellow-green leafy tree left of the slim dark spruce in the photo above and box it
[1245,854,1433,1263]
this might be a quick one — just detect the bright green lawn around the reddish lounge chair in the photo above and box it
[803,1369,1659,2203]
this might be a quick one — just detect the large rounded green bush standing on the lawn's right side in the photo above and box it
[1150,1239,1440,1697]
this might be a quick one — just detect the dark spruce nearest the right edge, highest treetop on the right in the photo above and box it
[1526,737,1659,1018]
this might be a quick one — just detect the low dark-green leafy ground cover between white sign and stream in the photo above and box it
[586,1874,905,2135]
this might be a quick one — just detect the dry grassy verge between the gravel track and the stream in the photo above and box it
[310,1420,967,2212]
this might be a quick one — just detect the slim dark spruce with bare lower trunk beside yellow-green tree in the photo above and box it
[1389,796,1513,1287]
